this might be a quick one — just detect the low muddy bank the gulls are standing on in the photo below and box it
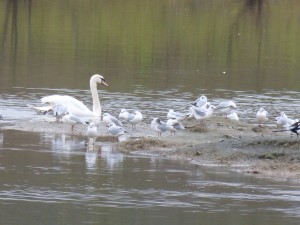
[2,117,300,181]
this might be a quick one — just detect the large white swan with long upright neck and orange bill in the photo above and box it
[31,74,108,117]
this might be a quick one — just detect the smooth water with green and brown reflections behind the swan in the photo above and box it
[0,0,300,92]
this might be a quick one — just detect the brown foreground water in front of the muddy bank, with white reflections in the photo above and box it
[0,131,300,225]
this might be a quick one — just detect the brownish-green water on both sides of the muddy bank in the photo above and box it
[0,0,300,225]
